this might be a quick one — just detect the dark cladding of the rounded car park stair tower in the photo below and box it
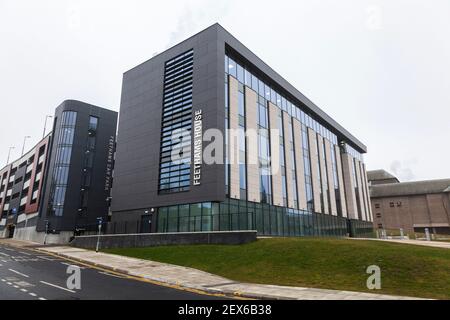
[37,100,117,231]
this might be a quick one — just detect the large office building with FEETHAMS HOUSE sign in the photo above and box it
[111,24,372,236]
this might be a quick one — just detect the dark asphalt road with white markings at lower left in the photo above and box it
[0,244,225,300]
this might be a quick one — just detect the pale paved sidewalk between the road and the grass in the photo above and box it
[0,239,428,300]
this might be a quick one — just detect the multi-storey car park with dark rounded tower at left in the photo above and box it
[0,100,117,243]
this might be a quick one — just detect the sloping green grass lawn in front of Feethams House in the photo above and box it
[105,238,450,299]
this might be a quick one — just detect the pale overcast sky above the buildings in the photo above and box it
[0,0,450,181]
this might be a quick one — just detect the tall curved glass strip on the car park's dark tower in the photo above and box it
[49,111,77,216]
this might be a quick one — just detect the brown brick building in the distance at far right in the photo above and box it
[367,170,450,234]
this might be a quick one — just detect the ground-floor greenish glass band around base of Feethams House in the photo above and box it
[157,199,356,237]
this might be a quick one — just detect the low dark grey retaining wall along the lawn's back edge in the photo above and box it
[70,231,256,249]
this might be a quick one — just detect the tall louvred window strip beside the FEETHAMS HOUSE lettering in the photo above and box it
[159,50,194,193]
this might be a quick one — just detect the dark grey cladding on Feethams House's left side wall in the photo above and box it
[112,28,225,215]
